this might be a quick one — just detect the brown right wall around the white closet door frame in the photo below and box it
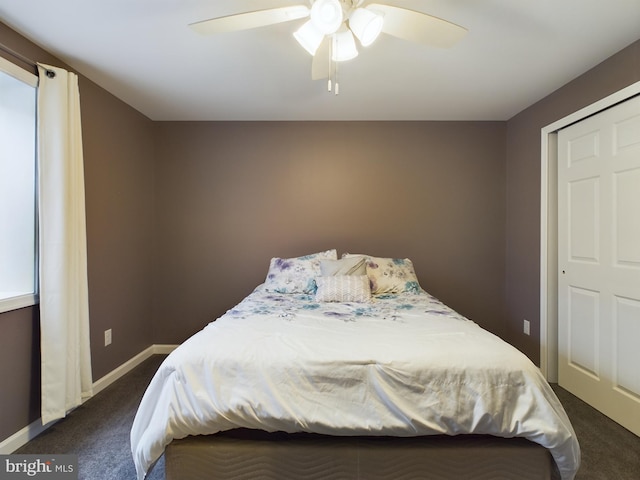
[506,40,640,362]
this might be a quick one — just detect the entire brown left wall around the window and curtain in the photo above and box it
[0,23,154,441]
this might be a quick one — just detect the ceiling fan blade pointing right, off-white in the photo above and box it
[368,3,467,48]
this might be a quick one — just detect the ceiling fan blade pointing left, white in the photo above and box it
[189,5,309,35]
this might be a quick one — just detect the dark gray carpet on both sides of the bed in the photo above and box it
[16,355,640,480]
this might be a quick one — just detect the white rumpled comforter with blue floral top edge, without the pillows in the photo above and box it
[131,287,580,479]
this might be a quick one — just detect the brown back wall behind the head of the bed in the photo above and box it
[153,122,505,343]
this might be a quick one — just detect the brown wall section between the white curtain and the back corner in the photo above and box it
[80,81,154,380]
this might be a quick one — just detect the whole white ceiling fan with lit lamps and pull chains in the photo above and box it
[189,0,467,95]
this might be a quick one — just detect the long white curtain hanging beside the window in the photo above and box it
[38,64,93,424]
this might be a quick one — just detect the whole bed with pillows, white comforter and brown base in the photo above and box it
[131,250,580,480]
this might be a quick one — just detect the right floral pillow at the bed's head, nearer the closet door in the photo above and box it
[342,253,421,295]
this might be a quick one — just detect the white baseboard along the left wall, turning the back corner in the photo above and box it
[0,345,177,455]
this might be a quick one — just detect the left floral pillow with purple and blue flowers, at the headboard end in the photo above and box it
[264,249,338,294]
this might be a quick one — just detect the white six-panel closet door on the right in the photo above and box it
[558,97,640,435]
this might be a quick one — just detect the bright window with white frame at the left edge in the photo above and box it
[0,58,37,312]
